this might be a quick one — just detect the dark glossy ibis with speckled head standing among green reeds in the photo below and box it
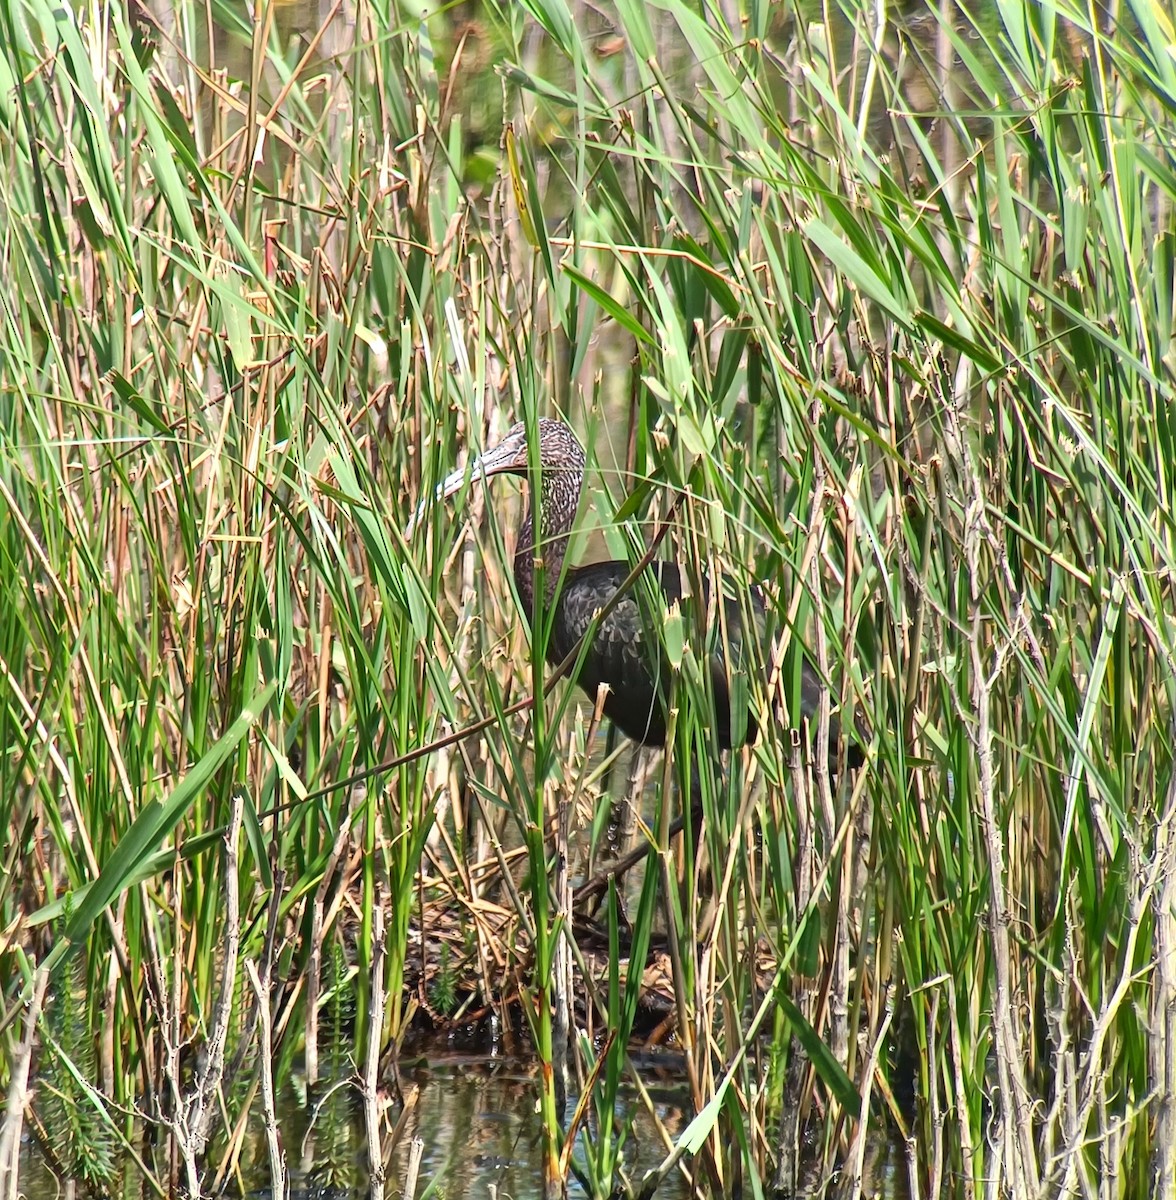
[427,419,849,749]
